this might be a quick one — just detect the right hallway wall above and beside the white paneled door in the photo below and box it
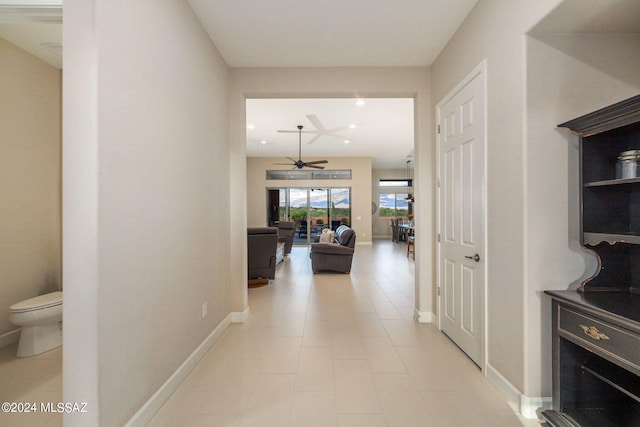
[432,0,560,402]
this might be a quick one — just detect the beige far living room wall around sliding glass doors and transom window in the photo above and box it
[247,157,371,244]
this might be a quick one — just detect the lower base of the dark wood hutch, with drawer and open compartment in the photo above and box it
[542,291,640,427]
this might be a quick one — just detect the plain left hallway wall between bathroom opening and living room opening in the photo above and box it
[63,0,231,426]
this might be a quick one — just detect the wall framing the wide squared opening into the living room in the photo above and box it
[229,68,435,319]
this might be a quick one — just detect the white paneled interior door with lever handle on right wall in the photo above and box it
[437,68,485,367]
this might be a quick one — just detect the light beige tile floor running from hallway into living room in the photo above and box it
[148,241,539,427]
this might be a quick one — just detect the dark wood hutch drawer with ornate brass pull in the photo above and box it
[558,306,640,372]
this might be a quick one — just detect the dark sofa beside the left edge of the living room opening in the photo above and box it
[247,227,278,281]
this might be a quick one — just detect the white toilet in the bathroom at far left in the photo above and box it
[9,292,62,357]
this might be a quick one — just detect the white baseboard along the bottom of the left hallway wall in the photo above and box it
[125,313,233,427]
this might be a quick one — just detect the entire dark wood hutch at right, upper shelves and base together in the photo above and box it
[543,95,640,427]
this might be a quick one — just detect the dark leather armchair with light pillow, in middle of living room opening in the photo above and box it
[310,225,356,274]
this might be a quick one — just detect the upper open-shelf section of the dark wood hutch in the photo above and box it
[559,96,640,292]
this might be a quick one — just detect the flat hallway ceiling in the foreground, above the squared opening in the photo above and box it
[189,0,477,67]
